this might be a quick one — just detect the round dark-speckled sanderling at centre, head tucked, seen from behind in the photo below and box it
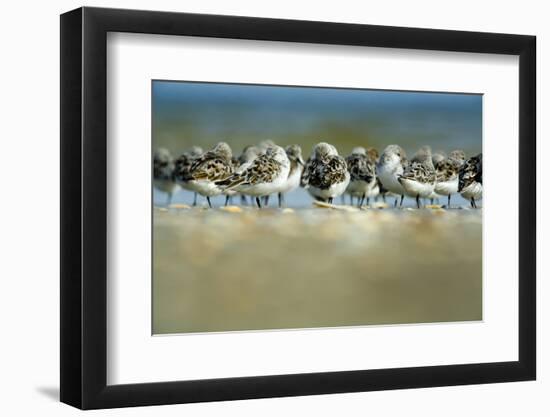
[302,142,350,204]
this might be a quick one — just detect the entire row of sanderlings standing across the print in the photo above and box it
[153,140,483,208]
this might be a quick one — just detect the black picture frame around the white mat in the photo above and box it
[60,7,536,409]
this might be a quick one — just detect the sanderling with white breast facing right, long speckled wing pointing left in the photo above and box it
[217,145,290,208]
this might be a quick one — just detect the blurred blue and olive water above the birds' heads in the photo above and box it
[151,81,483,161]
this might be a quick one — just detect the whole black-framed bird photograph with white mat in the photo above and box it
[60,7,536,409]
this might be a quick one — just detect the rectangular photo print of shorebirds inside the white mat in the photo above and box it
[152,80,483,335]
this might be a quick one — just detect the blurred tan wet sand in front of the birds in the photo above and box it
[153,205,482,334]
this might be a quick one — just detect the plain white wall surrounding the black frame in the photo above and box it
[0,0,550,417]
